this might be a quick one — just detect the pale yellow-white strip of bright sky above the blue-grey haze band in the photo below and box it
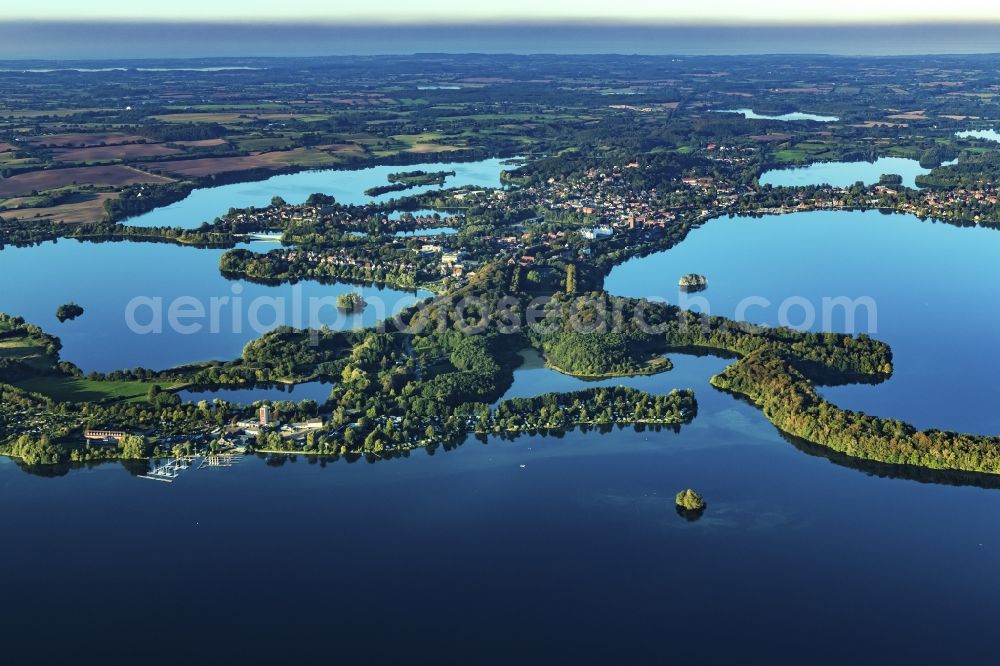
[7,0,1000,23]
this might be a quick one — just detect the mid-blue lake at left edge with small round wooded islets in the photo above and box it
[0,240,430,372]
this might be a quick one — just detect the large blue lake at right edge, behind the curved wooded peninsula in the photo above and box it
[605,211,1000,434]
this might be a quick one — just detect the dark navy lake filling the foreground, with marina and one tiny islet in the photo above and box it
[0,392,1000,665]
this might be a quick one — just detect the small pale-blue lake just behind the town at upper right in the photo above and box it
[760,157,954,188]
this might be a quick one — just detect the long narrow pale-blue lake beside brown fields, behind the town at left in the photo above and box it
[127,158,507,229]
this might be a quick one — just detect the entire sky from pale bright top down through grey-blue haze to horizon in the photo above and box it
[0,0,1000,60]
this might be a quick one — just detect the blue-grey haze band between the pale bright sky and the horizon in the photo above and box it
[0,21,1000,59]
